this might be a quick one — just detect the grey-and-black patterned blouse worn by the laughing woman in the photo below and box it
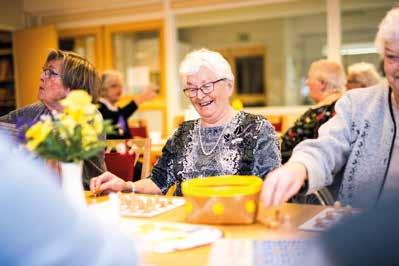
[150,112,281,196]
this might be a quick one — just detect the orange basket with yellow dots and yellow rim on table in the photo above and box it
[182,176,263,224]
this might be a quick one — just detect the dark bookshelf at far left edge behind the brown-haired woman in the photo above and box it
[0,31,15,115]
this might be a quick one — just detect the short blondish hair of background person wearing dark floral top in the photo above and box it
[309,59,346,92]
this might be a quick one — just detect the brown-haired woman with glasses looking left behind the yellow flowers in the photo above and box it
[0,50,106,188]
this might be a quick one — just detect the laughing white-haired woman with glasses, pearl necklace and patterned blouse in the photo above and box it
[90,49,281,195]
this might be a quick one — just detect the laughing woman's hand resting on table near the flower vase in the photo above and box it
[90,171,131,194]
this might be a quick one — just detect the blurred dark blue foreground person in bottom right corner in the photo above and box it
[310,200,399,266]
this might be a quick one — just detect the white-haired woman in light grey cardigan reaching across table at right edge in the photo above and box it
[262,8,399,208]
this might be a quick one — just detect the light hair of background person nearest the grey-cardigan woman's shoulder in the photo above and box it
[348,62,380,87]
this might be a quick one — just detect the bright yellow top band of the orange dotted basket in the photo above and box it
[182,175,263,197]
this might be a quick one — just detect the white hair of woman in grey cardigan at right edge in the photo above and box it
[374,8,399,56]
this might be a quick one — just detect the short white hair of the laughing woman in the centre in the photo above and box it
[179,48,234,83]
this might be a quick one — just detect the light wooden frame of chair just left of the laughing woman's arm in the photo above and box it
[106,138,151,179]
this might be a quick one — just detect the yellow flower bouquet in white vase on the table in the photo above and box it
[25,90,113,210]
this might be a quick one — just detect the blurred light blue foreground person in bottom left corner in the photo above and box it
[0,132,138,266]
